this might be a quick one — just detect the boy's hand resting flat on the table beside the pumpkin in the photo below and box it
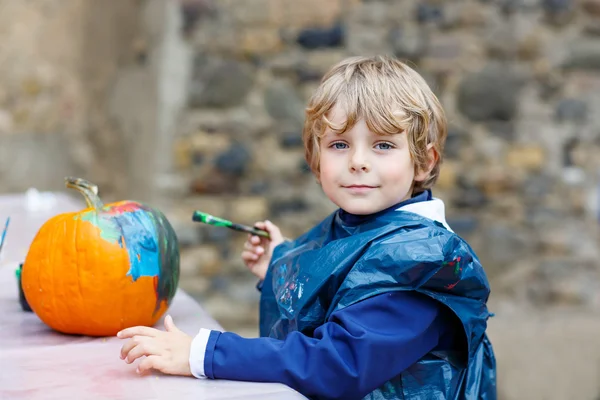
[117,315,192,376]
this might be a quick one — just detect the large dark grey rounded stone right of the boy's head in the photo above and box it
[457,63,519,121]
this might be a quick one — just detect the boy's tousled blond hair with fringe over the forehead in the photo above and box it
[302,56,447,193]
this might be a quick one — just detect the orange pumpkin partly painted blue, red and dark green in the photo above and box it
[21,178,179,336]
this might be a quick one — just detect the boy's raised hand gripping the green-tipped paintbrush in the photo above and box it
[242,221,284,279]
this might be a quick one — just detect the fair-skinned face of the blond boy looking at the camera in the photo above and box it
[319,106,426,215]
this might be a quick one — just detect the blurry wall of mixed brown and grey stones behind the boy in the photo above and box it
[174,0,600,324]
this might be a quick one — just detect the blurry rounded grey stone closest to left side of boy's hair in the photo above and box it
[264,81,305,126]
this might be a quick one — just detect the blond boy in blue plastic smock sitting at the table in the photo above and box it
[119,57,496,399]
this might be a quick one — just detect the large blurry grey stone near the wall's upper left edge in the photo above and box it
[189,55,255,108]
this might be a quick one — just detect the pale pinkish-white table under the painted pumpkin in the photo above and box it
[0,193,305,400]
